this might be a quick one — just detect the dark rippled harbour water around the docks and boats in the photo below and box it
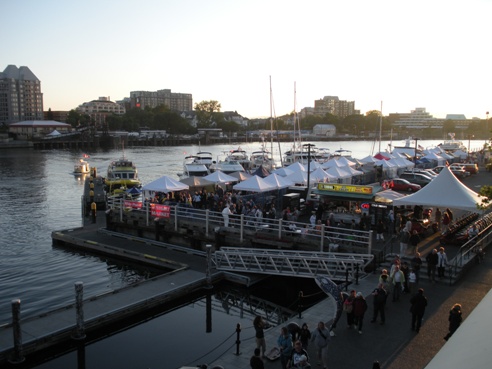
[0,141,483,369]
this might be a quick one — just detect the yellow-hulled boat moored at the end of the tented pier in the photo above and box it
[104,156,142,193]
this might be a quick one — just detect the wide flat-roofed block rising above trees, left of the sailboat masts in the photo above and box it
[130,90,193,111]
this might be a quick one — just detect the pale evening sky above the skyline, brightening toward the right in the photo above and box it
[0,0,492,119]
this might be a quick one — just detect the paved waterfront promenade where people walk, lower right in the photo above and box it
[209,255,492,369]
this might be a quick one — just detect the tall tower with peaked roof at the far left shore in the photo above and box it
[0,65,43,124]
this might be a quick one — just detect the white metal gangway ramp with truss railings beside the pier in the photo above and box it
[213,247,374,281]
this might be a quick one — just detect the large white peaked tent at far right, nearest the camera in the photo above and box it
[393,167,483,212]
